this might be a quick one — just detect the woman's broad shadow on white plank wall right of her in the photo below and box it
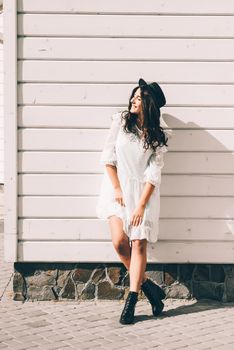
[148,113,234,263]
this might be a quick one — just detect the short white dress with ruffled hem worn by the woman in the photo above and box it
[96,112,167,243]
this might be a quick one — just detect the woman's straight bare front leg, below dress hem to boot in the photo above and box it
[129,239,147,292]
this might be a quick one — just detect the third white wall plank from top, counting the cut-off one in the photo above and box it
[18,37,234,61]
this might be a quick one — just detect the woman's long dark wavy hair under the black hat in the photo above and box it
[121,86,168,151]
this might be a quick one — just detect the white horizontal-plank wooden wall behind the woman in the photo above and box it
[6,0,234,263]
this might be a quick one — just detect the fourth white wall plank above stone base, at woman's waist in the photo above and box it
[18,174,234,196]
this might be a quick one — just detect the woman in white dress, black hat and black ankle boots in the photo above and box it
[96,79,167,324]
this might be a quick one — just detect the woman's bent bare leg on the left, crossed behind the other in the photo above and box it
[109,215,147,282]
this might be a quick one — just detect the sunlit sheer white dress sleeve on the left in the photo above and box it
[100,113,121,166]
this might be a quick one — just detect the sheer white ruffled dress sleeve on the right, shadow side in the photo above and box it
[144,146,168,188]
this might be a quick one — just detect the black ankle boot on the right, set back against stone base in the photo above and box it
[141,278,166,316]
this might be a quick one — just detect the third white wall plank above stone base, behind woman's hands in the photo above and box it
[18,196,234,219]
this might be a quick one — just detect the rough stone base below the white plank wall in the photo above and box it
[13,263,234,302]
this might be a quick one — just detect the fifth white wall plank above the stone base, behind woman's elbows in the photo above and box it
[18,152,234,175]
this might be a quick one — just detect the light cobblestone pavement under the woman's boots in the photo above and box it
[0,189,234,350]
